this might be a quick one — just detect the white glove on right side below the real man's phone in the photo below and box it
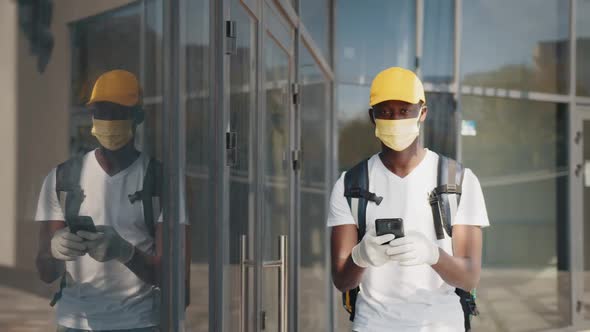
[387,231,440,266]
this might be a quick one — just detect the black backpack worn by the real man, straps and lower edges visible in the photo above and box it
[342,156,479,331]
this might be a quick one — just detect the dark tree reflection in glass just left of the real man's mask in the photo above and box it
[338,115,381,171]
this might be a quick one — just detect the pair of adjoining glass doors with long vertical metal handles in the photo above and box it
[225,0,294,332]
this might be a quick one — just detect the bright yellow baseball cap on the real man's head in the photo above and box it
[369,67,426,106]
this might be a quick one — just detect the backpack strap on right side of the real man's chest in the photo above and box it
[429,156,465,240]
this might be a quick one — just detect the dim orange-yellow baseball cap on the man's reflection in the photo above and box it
[86,69,140,106]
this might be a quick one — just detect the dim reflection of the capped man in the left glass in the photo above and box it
[35,70,173,331]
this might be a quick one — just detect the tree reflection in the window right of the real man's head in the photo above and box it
[462,96,567,177]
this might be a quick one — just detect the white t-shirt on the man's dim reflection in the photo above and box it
[35,151,160,330]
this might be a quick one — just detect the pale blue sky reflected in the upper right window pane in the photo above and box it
[461,0,569,74]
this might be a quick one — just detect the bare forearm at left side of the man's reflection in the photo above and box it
[35,220,66,284]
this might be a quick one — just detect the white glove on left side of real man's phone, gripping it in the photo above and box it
[352,232,395,268]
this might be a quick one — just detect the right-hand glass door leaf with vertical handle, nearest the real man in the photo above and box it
[260,4,294,332]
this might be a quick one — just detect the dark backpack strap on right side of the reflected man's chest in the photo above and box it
[128,158,162,237]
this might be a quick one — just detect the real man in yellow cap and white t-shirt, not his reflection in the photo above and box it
[327,67,489,332]
